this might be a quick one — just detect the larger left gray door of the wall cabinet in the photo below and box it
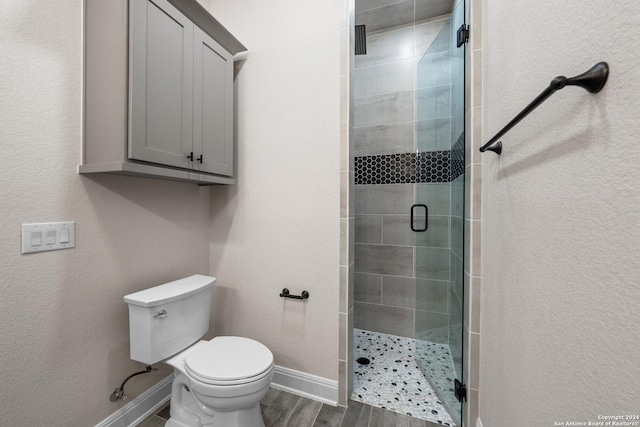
[129,0,194,168]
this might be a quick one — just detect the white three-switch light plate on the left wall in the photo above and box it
[22,221,76,254]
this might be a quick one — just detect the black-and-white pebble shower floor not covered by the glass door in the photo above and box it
[351,329,456,427]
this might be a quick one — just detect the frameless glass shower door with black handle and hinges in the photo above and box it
[411,1,464,425]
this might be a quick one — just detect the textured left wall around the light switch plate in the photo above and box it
[0,0,210,427]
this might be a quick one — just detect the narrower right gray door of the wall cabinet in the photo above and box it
[193,27,233,176]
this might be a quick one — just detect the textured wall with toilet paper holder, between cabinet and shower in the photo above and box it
[210,0,346,380]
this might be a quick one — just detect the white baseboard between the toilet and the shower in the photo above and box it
[271,365,338,406]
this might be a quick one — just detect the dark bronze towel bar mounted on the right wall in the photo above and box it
[480,62,609,154]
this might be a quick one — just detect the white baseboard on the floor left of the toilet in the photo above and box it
[96,374,173,427]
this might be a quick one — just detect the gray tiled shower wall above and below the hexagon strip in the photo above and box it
[353,0,451,343]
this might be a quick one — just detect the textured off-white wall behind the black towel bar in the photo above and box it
[480,0,640,427]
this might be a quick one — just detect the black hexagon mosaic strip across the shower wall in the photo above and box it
[354,133,464,185]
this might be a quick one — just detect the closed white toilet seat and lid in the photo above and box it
[184,337,273,386]
